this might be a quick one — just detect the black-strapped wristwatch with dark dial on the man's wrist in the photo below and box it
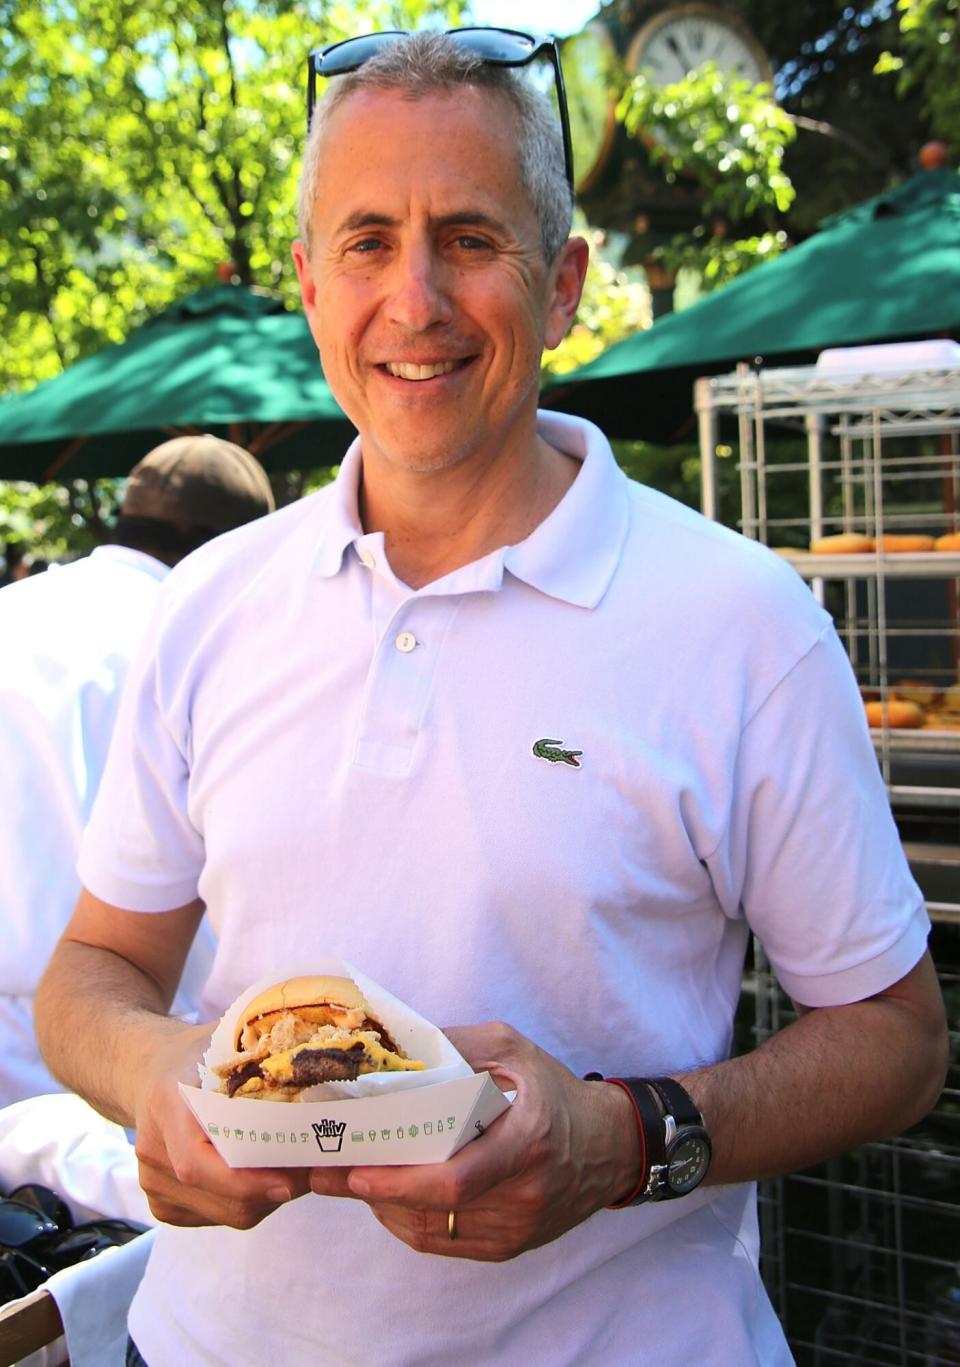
[593,1073,712,1210]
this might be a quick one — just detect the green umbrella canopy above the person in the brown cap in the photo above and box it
[0,284,353,481]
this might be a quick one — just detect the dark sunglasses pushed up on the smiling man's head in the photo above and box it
[306,29,573,194]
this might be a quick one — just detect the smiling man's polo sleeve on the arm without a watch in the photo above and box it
[77,614,204,912]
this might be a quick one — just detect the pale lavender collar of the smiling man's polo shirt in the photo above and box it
[315,411,629,607]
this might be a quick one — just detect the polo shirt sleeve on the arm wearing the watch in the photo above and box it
[707,626,930,1006]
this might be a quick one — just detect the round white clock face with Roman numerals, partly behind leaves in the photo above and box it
[626,4,773,86]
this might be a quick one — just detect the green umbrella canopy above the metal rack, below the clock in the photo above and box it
[543,171,960,442]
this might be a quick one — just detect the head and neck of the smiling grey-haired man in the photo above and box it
[294,66,587,588]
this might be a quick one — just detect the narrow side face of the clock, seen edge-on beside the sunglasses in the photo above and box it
[561,19,617,191]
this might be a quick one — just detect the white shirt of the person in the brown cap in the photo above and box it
[0,545,211,1106]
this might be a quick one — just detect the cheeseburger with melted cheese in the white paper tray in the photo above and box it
[213,976,424,1102]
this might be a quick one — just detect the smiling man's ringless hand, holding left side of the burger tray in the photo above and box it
[129,1025,310,1229]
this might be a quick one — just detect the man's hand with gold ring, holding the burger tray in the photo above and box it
[312,1024,640,1262]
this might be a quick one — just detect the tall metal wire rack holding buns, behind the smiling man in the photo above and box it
[696,366,960,1367]
